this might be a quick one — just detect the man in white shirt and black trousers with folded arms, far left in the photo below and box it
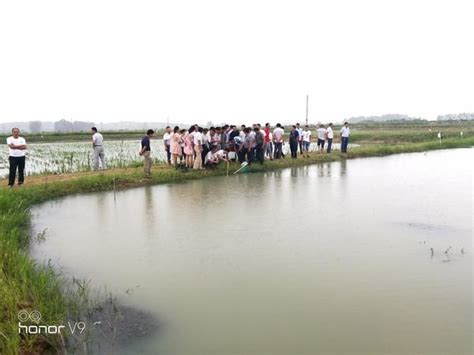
[7,127,26,187]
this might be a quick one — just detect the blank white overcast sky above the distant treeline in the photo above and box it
[0,0,474,123]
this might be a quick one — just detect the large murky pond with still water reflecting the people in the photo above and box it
[31,149,473,354]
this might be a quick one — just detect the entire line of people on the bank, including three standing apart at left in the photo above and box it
[7,122,350,187]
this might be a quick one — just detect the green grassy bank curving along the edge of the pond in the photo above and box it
[0,130,474,354]
